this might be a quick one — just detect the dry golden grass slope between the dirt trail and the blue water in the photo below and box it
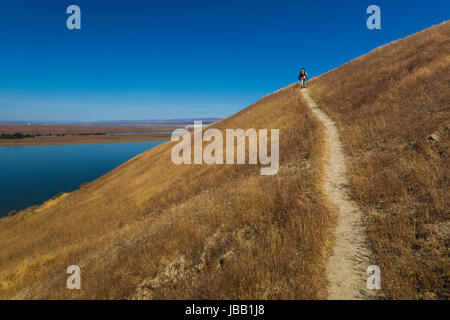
[0,87,335,299]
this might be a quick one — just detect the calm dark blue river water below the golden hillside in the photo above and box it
[0,141,165,217]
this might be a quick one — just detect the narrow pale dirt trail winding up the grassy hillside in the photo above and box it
[301,89,375,300]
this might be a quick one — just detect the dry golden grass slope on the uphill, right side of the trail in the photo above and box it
[310,21,450,299]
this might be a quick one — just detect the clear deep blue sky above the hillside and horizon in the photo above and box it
[0,0,450,121]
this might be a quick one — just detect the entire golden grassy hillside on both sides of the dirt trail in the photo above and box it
[0,22,450,299]
